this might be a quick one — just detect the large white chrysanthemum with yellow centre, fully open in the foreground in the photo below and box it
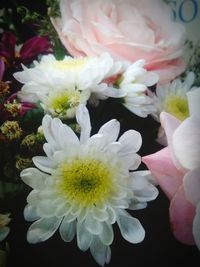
[21,105,158,265]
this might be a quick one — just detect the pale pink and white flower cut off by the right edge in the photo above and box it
[143,90,200,249]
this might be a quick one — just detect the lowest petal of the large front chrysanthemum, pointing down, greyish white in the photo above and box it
[90,236,111,266]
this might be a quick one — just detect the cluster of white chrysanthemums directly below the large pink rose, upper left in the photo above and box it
[14,53,158,119]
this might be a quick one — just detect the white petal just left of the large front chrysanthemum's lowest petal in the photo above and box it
[77,222,92,251]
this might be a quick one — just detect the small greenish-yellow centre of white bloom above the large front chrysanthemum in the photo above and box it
[48,91,80,114]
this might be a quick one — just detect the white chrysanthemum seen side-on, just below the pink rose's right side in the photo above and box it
[119,60,158,117]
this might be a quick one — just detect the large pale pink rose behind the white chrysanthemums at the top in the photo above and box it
[52,0,186,83]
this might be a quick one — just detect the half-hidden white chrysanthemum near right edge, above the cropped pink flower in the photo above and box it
[153,72,196,121]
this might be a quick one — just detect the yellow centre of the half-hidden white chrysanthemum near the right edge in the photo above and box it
[164,95,189,121]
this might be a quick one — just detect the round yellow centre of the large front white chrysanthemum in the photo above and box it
[58,159,114,207]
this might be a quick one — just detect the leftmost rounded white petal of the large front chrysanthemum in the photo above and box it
[20,168,48,190]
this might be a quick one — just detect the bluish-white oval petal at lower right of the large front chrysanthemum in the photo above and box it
[117,212,145,244]
